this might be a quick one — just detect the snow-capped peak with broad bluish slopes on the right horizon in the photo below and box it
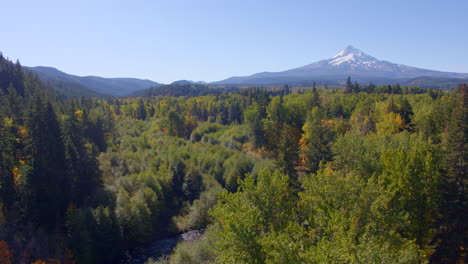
[215,46,468,85]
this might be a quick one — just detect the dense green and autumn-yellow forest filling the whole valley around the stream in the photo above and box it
[0,56,468,263]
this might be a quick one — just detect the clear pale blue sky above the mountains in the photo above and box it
[0,0,468,83]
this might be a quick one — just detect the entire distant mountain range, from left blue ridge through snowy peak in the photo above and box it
[19,46,468,94]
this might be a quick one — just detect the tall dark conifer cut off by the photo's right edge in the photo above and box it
[431,85,468,263]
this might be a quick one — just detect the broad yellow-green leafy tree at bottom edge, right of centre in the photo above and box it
[300,168,420,263]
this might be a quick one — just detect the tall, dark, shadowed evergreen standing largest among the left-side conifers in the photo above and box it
[26,97,70,228]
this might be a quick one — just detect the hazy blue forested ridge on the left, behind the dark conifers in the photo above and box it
[25,66,161,96]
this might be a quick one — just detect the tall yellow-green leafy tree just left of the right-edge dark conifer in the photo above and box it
[378,137,440,247]
